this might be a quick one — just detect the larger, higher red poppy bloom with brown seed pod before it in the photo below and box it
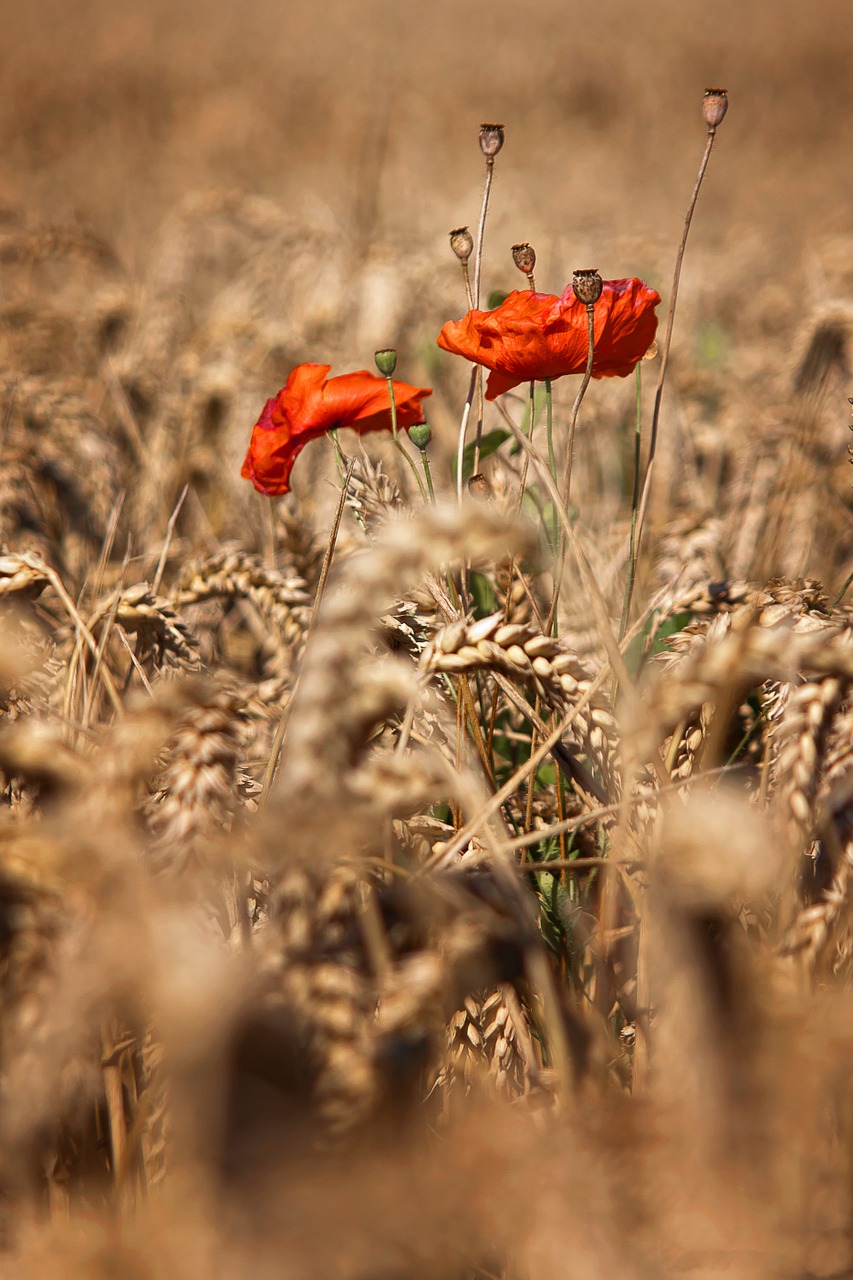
[438,279,661,399]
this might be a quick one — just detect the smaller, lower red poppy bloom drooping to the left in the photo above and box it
[240,365,432,497]
